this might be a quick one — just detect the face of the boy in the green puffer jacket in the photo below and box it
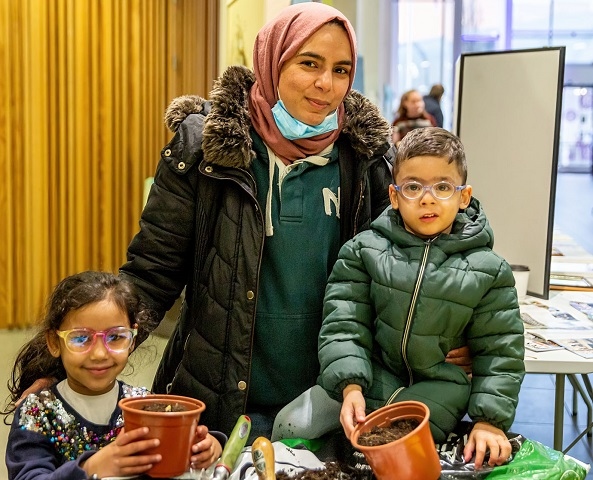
[389,156,472,238]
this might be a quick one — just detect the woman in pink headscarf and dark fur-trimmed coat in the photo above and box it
[121,3,468,439]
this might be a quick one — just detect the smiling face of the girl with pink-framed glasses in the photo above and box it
[47,300,133,395]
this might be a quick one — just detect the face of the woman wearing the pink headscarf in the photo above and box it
[278,24,353,125]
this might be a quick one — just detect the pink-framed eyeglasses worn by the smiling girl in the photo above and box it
[56,327,138,353]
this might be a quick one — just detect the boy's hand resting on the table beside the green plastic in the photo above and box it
[463,422,513,470]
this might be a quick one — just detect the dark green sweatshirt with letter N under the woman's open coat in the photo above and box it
[248,133,341,410]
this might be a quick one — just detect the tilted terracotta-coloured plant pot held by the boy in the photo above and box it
[350,401,441,480]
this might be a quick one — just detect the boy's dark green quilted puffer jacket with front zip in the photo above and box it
[319,199,525,442]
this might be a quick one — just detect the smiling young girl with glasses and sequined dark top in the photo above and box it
[4,271,222,480]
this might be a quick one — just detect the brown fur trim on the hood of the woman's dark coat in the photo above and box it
[165,66,391,168]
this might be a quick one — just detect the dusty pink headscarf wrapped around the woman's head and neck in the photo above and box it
[249,2,356,163]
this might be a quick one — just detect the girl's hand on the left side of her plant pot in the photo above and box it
[81,427,161,478]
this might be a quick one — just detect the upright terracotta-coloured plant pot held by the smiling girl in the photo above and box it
[119,395,206,478]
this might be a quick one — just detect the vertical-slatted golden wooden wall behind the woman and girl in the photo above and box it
[0,0,219,328]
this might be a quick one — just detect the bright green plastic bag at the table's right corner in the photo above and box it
[486,439,587,480]
